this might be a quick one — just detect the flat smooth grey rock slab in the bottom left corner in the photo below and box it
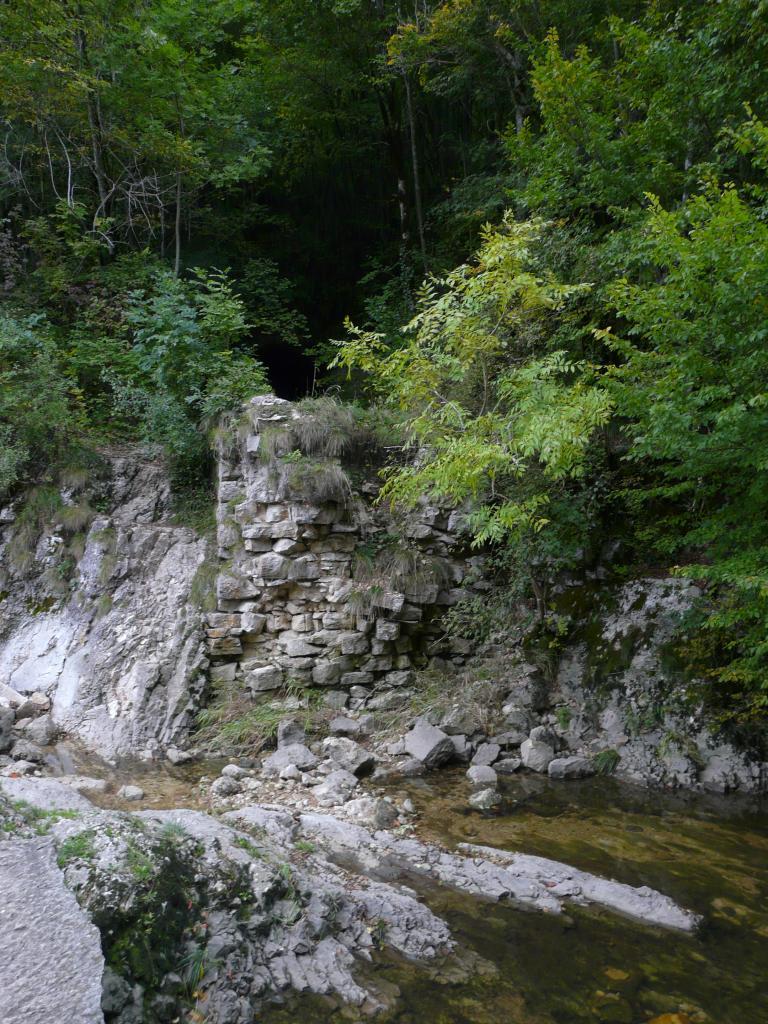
[0,838,104,1024]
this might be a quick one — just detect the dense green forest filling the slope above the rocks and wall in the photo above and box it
[0,0,768,732]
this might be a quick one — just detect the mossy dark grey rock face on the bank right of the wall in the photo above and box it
[505,577,768,794]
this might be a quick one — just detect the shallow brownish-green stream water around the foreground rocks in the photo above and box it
[48,752,768,1024]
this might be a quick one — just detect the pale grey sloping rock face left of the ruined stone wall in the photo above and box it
[0,454,206,757]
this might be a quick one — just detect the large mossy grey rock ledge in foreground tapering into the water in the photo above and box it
[0,770,697,1024]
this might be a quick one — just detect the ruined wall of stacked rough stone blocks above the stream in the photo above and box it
[207,395,482,707]
